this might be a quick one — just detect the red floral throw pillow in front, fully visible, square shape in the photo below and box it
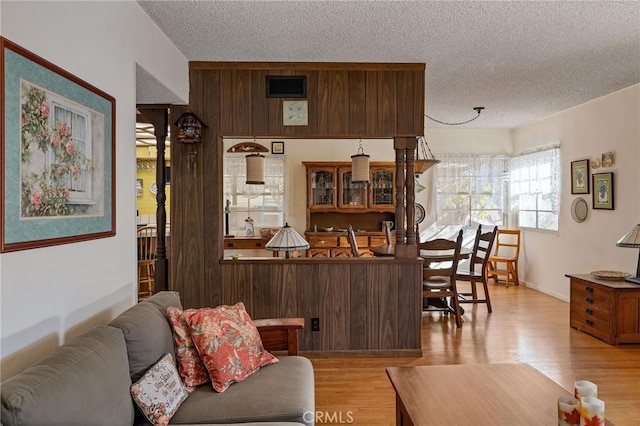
[185,303,278,392]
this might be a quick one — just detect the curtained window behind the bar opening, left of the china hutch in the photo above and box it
[224,154,287,235]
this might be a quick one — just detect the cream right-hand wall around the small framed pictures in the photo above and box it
[514,85,640,300]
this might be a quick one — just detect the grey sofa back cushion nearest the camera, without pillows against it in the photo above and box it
[1,326,134,426]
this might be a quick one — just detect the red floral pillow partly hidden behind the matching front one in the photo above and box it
[167,306,210,392]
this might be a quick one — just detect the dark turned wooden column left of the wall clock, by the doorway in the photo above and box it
[137,105,169,293]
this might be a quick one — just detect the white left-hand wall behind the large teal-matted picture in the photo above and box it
[0,1,188,379]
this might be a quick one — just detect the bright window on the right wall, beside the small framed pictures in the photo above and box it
[510,146,560,231]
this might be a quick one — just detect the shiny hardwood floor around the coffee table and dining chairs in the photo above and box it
[311,281,640,426]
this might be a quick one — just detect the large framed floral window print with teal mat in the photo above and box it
[0,37,116,252]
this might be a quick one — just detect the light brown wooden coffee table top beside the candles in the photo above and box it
[387,363,571,425]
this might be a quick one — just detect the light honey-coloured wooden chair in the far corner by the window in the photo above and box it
[487,229,521,288]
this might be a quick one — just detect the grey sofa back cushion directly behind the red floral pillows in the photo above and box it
[109,291,182,381]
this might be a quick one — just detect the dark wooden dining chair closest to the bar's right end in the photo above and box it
[420,230,462,328]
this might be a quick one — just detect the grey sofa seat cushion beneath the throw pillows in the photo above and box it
[171,356,315,426]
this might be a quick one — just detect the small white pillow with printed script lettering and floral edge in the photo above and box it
[131,354,189,426]
